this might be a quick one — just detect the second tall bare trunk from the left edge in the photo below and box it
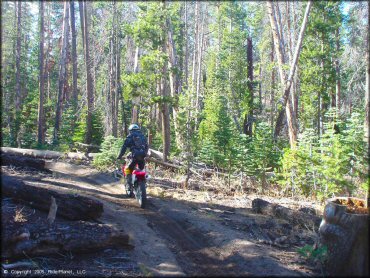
[37,1,45,145]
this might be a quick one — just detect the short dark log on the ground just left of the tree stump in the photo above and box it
[252,198,321,227]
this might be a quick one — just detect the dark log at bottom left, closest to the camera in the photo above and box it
[1,204,129,258]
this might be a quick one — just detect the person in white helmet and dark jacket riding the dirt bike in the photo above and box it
[117,124,149,188]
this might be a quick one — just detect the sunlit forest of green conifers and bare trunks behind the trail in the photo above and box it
[1,1,369,200]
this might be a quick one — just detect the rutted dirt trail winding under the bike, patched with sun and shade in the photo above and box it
[13,162,315,276]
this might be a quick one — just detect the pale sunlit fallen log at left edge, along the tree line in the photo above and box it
[1,147,89,160]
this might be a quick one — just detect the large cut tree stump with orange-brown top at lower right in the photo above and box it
[319,197,369,276]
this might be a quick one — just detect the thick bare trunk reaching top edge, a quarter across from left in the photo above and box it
[83,2,94,144]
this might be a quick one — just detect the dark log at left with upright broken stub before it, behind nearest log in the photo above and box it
[1,175,103,220]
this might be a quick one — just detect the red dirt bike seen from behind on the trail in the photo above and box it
[114,155,150,208]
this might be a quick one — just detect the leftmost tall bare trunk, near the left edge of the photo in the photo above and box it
[13,1,22,146]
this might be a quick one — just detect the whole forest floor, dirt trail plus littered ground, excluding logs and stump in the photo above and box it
[2,162,321,277]
